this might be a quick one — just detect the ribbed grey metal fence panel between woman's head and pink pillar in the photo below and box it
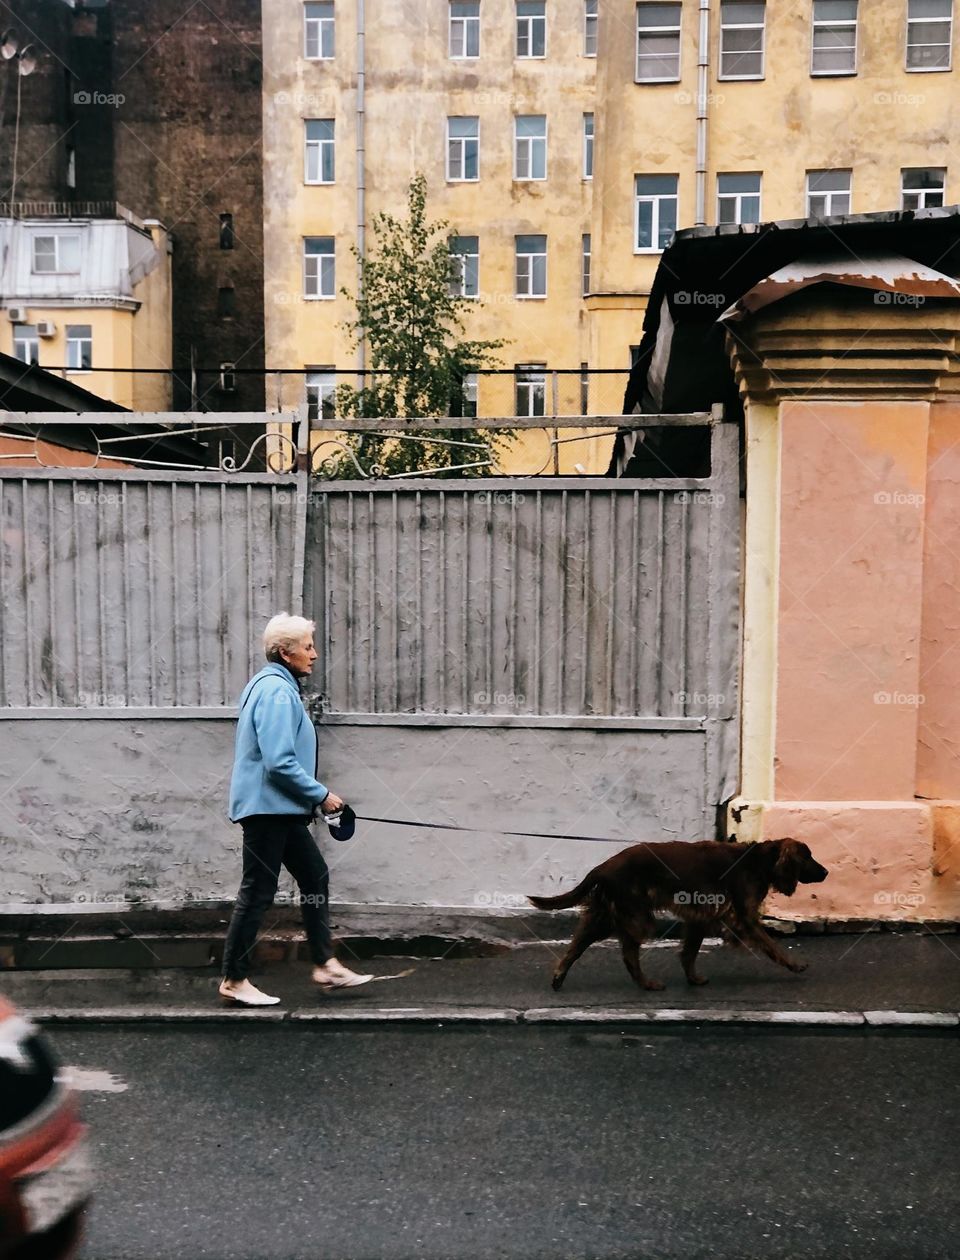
[305,463,738,718]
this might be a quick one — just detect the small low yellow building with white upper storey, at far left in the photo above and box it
[0,202,173,411]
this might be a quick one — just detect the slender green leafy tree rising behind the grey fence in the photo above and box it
[331,174,513,478]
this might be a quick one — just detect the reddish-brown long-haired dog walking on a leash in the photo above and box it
[529,839,829,989]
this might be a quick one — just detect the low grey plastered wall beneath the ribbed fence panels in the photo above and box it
[0,717,704,912]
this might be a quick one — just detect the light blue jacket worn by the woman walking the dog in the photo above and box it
[229,664,326,823]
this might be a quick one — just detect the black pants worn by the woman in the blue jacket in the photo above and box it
[223,814,334,980]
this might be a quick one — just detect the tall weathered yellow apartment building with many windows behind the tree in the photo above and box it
[263,0,960,471]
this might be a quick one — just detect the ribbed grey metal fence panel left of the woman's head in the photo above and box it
[0,470,299,709]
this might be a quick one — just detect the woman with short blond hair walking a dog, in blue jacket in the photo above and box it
[219,612,373,1007]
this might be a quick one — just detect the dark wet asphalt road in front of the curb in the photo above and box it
[54,1024,960,1260]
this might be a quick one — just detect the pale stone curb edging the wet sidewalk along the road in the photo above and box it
[24,1005,960,1028]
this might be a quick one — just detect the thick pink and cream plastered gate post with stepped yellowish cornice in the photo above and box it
[728,287,960,921]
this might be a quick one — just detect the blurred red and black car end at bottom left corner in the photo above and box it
[0,998,92,1260]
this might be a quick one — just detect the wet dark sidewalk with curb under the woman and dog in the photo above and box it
[0,932,960,1028]
